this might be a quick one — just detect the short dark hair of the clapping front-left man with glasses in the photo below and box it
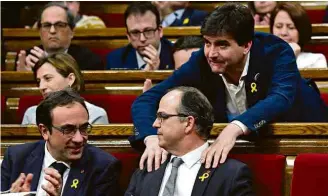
[36,88,89,133]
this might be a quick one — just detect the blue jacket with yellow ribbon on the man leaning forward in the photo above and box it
[129,33,328,148]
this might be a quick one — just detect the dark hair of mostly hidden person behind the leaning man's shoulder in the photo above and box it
[173,35,204,53]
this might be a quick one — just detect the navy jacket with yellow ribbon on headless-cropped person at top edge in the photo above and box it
[170,8,208,27]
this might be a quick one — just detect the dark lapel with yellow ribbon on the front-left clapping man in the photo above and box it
[62,146,88,196]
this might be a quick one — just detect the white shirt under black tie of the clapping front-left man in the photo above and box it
[36,142,71,196]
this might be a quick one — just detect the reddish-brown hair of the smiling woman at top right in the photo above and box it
[270,2,312,48]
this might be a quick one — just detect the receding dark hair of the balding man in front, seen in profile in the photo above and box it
[168,86,214,140]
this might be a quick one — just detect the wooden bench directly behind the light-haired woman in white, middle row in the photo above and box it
[1,69,328,124]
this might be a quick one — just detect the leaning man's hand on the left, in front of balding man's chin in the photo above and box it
[139,135,168,172]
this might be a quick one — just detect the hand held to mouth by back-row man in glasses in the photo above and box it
[143,44,161,71]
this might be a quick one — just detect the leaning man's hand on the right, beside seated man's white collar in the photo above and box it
[201,123,243,169]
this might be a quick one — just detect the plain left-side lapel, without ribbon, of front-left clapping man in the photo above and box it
[23,141,45,191]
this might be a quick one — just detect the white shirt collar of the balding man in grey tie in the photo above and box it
[170,142,209,169]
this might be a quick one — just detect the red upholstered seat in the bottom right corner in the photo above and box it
[291,154,328,196]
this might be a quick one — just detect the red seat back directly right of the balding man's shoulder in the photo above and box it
[229,154,286,196]
